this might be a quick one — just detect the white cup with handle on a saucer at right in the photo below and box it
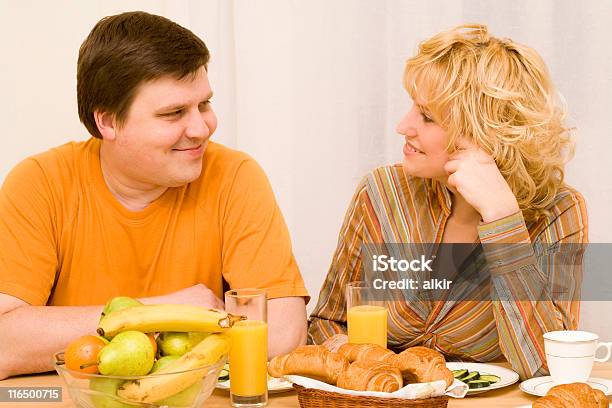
[544,330,612,384]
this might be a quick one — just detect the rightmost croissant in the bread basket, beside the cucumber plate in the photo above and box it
[386,346,454,387]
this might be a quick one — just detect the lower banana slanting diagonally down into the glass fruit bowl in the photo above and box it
[117,334,230,403]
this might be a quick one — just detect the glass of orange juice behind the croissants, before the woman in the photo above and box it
[346,281,387,348]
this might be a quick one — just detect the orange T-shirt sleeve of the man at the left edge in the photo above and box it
[0,158,57,305]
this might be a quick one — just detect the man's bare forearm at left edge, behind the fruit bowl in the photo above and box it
[0,306,102,379]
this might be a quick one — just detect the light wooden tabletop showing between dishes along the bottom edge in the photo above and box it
[0,362,612,408]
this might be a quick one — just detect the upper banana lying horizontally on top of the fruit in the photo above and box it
[96,305,246,338]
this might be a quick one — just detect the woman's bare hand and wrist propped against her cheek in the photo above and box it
[444,139,519,222]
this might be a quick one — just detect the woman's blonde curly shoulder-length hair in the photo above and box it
[404,25,574,221]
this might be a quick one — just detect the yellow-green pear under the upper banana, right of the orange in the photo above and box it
[98,330,155,375]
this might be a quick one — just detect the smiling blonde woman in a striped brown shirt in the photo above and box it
[309,25,587,379]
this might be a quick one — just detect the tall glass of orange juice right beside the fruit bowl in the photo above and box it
[225,289,268,407]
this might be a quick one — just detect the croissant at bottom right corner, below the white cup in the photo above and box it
[532,383,608,408]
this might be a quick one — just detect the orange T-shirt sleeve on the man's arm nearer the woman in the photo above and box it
[221,159,308,300]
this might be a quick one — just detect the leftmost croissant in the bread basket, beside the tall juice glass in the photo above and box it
[268,346,349,385]
